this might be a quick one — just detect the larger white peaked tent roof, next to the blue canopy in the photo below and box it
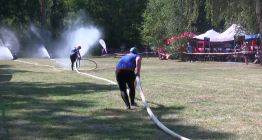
[210,24,245,42]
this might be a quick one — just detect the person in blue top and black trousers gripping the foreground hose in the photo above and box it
[116,47,142,110]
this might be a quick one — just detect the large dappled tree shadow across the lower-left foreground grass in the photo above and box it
[0,64,233,140]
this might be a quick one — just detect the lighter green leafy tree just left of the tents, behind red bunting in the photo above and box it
[141,0,200,56]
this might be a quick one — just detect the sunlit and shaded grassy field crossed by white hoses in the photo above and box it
[0,58,262,140]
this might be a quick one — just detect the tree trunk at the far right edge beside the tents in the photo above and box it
[254,0,262,65]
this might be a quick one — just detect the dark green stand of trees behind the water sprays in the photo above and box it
[0,0,148,53]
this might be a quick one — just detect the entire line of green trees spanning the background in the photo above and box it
[0,0,262,59]
